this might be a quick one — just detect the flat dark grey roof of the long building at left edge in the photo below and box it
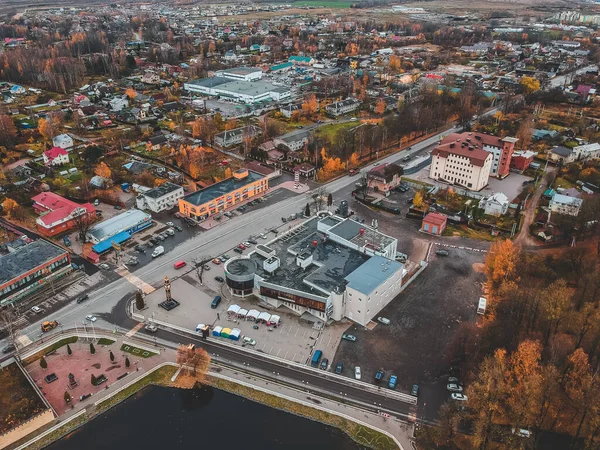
[0,239,67,284]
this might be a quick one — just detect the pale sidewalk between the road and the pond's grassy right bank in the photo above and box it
[209,366,413,450]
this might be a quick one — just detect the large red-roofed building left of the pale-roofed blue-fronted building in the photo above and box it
[31,192,96,236]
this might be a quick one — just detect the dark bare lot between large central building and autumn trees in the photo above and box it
[334,247,484,390]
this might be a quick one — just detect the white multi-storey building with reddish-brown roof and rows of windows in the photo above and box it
[429,135,494,191]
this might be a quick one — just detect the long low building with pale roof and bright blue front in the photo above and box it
[86,209,152,255]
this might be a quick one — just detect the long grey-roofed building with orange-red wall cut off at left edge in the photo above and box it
[0,239,73,307]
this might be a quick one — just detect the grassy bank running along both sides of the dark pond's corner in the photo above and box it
[8,363,400,450]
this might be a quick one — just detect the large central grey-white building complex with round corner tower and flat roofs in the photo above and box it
[225,215,407,325]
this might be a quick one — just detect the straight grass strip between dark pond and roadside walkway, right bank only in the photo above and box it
[208,377,398,450]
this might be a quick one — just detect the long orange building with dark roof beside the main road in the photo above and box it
[179,169,269,220]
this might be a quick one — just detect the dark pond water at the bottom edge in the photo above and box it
[47,386,363,450]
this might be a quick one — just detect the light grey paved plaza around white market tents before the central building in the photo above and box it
[142,272,349,364]
